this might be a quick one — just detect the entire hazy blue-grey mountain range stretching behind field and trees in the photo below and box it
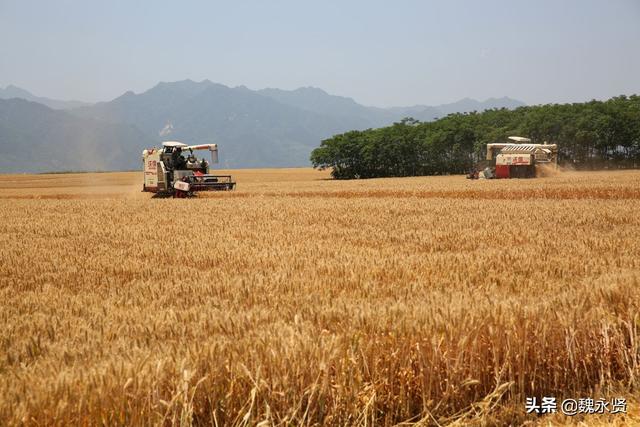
[0,80,524,172]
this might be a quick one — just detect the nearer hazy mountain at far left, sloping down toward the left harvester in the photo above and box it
[0,98,153,173]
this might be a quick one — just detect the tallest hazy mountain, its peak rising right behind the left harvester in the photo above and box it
[71,80,360,167]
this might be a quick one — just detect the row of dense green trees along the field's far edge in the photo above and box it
[311,95,640,179]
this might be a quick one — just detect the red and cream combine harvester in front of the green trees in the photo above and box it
[467,136,558,179]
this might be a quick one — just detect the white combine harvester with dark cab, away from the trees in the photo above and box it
[142,141,236,198]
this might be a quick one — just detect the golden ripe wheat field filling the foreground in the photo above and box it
[0,169,640,426]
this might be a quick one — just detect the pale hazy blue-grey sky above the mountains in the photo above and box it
[0,0,640,107]
